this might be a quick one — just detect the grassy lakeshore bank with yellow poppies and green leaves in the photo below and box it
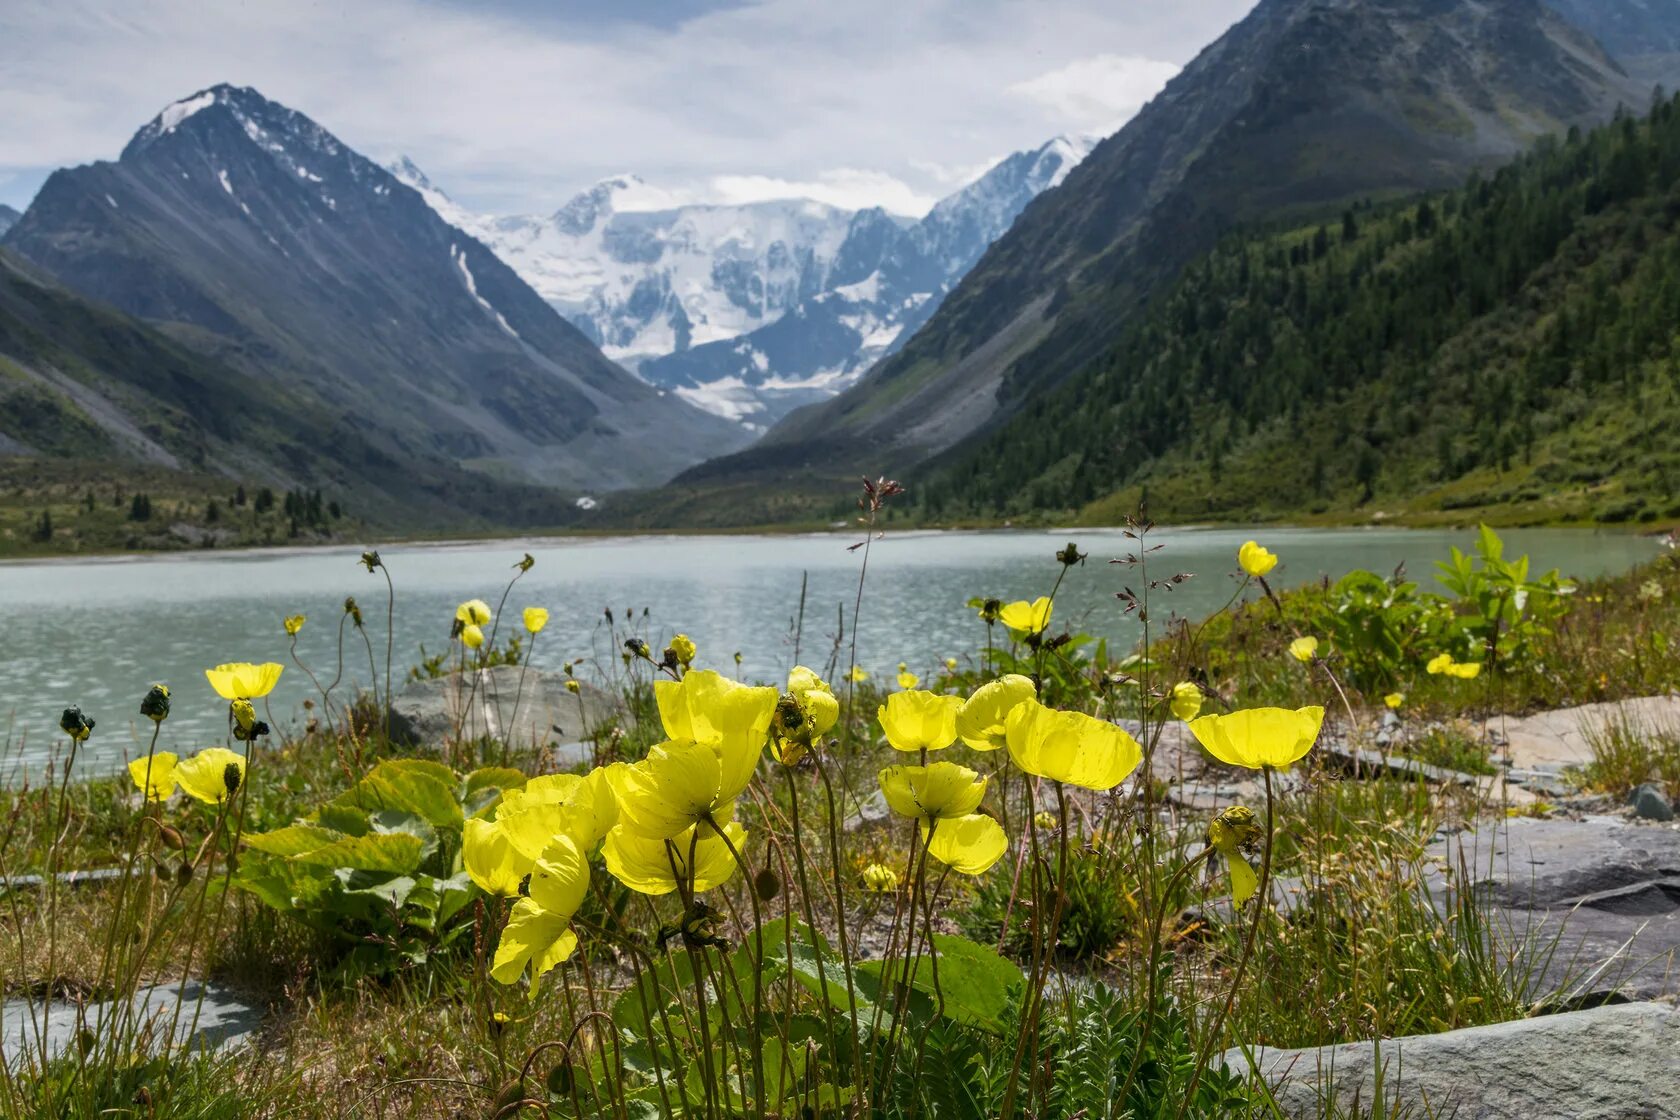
[0,529,1680,1118]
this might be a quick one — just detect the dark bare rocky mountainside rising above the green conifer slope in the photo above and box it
[679,0,1650,500]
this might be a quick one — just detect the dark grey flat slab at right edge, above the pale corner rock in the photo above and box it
[1428,818,1680,1002]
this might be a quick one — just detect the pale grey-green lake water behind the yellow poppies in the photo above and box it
[0,529,1658,769]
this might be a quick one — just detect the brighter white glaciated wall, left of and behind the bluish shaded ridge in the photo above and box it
[390,156,852,369]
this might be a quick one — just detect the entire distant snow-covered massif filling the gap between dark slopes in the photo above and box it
[390,138,1092,424]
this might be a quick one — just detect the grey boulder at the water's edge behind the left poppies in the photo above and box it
[391,665,618,764]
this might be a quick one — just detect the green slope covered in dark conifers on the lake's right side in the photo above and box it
[919,102,1680,521]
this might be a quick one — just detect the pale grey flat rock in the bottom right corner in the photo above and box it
[1220,1002,1680,1120]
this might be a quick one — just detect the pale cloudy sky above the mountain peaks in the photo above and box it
[0,0,1253,213]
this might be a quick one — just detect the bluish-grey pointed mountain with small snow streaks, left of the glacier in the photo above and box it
[3,86,739,505]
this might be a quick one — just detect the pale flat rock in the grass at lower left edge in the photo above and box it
[0,981,262,1070]
